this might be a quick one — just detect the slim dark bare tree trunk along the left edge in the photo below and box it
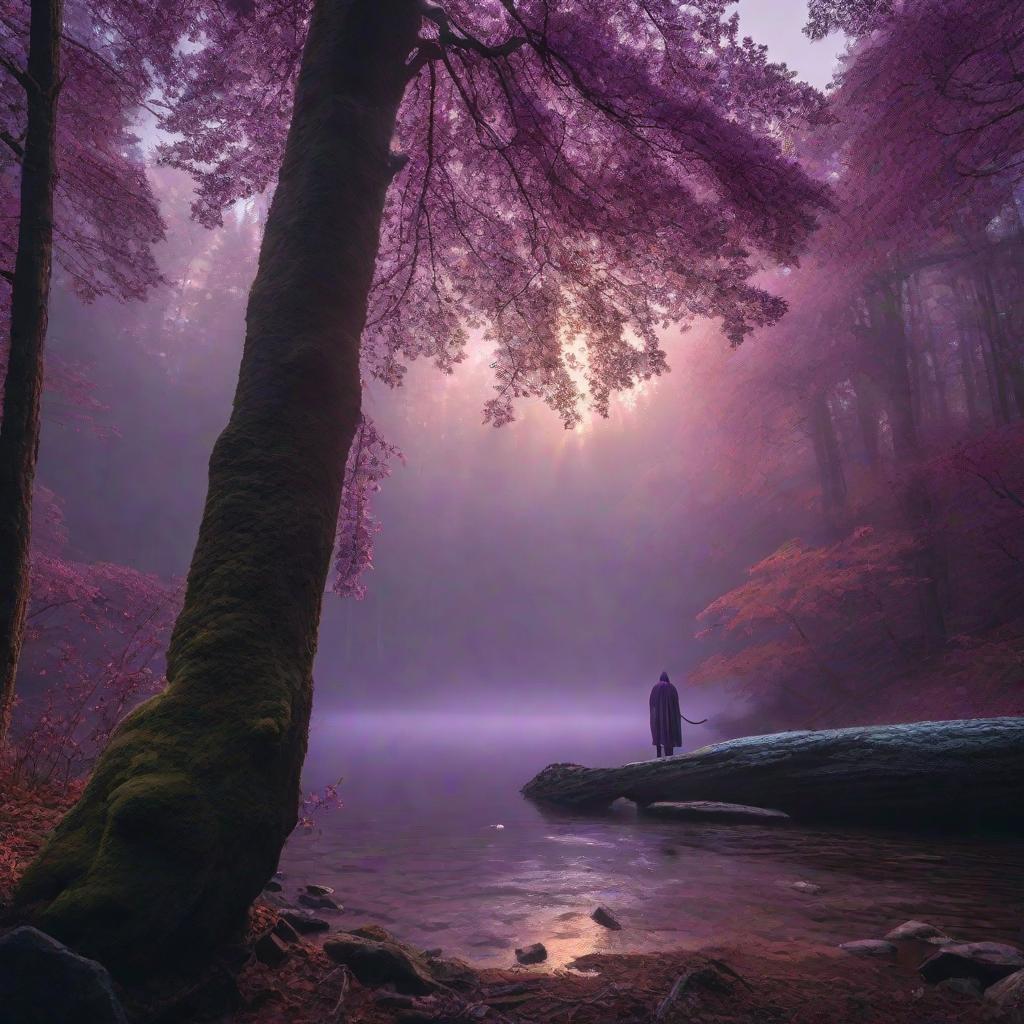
[0,0,63,748]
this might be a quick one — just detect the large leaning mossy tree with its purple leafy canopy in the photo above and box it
[16,0,825,977]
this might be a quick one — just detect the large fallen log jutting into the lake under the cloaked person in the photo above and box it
[522,718,1024,831]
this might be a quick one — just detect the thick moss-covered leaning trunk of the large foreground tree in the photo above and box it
[16,0,420,979]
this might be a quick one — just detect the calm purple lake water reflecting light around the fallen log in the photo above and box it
[282,709,1024,967]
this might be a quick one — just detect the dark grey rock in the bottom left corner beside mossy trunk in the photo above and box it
[0,928,128,1024]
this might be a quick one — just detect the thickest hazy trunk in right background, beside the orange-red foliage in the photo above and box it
[871,282,946,646]
